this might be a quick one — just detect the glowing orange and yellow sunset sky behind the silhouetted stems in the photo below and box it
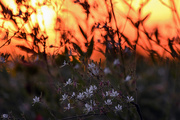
[0,0,180,60]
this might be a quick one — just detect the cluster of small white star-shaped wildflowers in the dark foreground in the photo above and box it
[33,59,134,118]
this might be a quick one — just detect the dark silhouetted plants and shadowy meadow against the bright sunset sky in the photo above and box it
[0,0,180,120]
